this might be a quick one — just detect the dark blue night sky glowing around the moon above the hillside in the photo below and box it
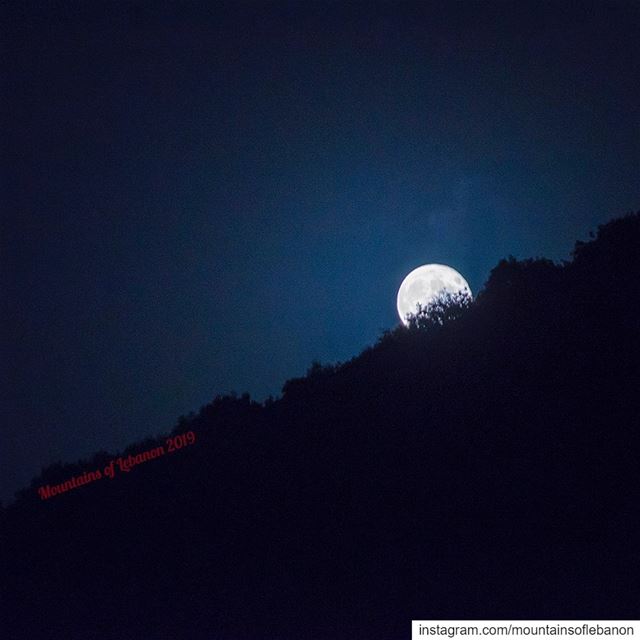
[0,2,640,501]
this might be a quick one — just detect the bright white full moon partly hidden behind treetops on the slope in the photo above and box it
[398,264,471,325]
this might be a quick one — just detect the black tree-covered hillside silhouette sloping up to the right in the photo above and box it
[0,213,640,640]
